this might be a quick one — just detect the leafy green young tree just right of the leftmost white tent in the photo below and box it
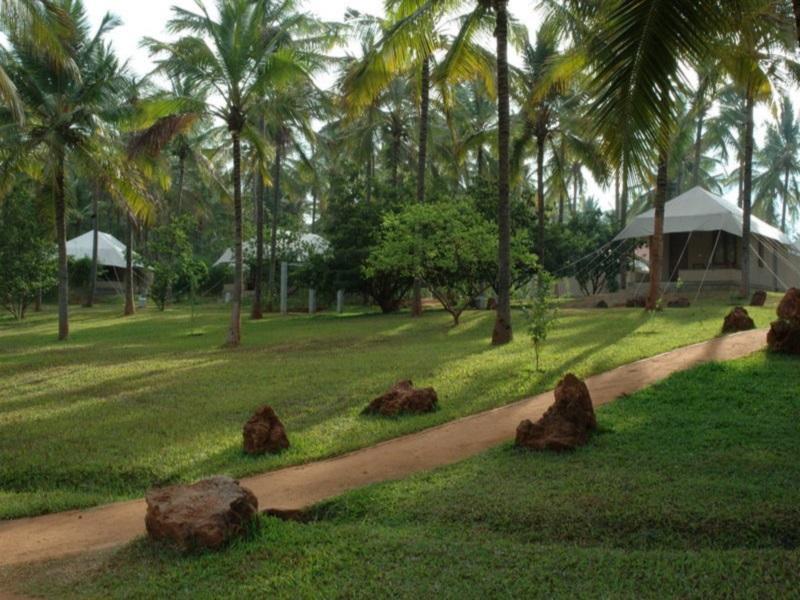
[150,217,208,310]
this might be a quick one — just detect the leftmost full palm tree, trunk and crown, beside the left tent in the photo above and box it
[4,0,149,340]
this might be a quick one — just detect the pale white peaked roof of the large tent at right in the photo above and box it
[614,187,791,245]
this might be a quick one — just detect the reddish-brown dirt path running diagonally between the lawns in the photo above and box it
[0,330,766,566]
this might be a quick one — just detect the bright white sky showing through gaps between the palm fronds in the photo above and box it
[84,0,800,237]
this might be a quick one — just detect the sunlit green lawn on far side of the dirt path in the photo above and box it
[0,298,775,519]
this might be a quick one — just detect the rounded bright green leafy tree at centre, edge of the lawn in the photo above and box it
[366,201,512,325]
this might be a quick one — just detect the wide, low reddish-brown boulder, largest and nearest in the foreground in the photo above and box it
[144,476,258,550]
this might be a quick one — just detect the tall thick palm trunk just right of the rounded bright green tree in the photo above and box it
[492,0,513,345]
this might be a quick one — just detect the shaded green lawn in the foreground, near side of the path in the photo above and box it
[7,353,800,598]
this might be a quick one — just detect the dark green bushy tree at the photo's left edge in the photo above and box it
[0,196,55,319]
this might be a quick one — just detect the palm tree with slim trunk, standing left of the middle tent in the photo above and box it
[145,0,310,347]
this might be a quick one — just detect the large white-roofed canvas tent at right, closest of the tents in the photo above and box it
[615,187,800,289]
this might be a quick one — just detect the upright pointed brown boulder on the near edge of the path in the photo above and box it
[516,373,597,452]
